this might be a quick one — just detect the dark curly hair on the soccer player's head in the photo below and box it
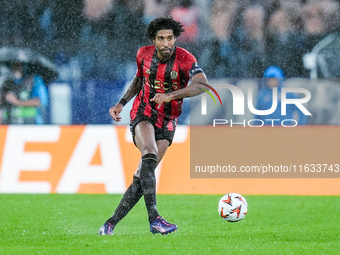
[146,16,184,40]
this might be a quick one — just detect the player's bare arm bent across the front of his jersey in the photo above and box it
[151,72,208,107]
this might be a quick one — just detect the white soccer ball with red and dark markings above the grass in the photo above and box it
[218,193,248,222]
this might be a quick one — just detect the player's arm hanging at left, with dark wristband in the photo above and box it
[109,76,143,122]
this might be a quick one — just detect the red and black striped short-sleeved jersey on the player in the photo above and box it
[130,45,203,130]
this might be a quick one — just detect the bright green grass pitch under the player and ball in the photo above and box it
[0,194,340,255]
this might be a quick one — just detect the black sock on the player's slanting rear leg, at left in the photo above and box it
[106,176,143,226]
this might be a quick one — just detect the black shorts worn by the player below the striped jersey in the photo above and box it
[130,115,175,146]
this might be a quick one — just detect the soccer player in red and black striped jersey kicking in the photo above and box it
[99,17,207,235]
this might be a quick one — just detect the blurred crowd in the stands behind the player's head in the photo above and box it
[0,0,340,81]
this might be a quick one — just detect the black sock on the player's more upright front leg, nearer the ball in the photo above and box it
[140,153,159,223]
